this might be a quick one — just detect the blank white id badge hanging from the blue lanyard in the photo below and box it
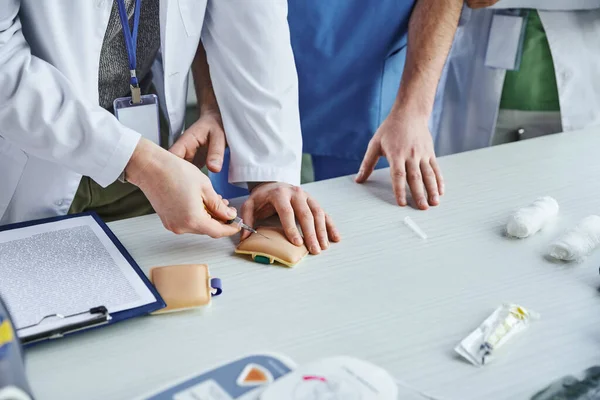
[113,94,161,146]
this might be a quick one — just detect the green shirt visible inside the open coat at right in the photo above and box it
[500,10,560,111]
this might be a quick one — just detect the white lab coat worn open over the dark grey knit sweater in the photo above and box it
[0,0,302,224]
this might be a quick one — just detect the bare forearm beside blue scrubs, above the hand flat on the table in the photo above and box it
[392,0,463,118]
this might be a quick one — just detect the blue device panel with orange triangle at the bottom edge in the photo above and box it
[147,355,293,400]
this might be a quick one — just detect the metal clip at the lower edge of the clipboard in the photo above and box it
[16,306,112,344]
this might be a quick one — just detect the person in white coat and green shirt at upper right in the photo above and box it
[431,0,600,156]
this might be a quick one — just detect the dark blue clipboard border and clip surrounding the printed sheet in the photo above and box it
[0,212,166,346]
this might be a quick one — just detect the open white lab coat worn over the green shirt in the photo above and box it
[431,0,600,156]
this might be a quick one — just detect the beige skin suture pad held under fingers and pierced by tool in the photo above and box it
[235,226,308,267]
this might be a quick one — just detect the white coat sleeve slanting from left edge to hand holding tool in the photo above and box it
[0,5,140,186]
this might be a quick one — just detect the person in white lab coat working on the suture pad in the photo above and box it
[0,0,339,253]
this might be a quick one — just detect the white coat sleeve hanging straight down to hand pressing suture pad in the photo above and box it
[202,0,302,185]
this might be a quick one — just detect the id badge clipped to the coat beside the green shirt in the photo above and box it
[485,10,527,71]
